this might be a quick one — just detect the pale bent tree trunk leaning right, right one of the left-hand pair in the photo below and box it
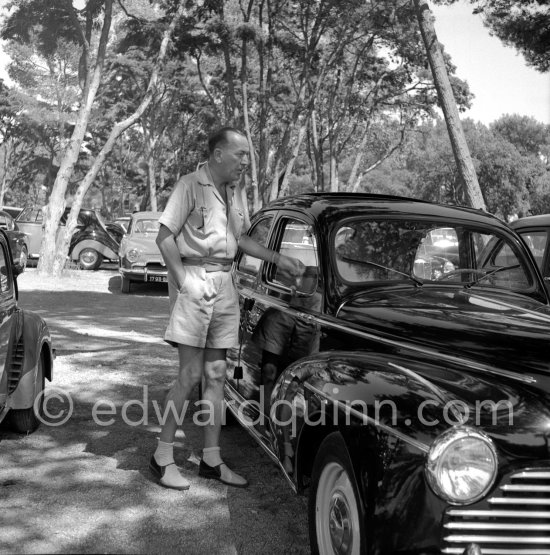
[51,4,184,272]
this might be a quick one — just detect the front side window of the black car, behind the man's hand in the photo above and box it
[269,219,319,295]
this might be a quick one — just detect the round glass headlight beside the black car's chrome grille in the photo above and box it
[426,427,498,505]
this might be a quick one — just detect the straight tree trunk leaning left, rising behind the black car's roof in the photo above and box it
[414,0,486,210]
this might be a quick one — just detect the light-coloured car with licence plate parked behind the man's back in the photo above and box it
[118,212,168,293]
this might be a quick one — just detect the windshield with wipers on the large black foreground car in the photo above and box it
[333,219,533,292]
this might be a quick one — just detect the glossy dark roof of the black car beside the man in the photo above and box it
[262,193,507,228]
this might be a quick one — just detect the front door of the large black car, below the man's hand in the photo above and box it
[229,215,322,443]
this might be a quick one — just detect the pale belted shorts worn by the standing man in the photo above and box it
[164,266,240,349]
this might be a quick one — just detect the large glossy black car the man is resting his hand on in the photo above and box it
[225,193,550,555]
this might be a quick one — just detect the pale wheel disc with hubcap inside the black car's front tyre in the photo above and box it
[315,462,360,555]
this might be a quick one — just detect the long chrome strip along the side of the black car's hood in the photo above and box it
[324,310,537,384]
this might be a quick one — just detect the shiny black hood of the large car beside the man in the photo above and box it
[338,287,550,379]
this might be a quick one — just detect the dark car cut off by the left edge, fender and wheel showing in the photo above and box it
[0,231,53,433]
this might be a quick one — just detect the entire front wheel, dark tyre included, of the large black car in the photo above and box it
[308,432,368,555]
